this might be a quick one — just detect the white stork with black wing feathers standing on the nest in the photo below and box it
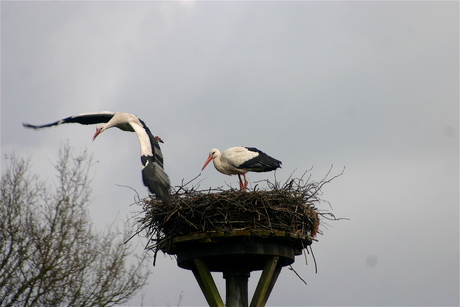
[201,146,281,190]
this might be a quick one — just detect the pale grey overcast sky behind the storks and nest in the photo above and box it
[1,1,459,306]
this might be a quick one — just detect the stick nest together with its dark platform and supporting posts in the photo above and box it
[140,177,335,306]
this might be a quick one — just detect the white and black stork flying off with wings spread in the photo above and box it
[23,111,170,200]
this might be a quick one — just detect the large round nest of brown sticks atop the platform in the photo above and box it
[140,168,343,264]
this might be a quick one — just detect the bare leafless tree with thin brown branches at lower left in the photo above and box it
[0,145,149,306]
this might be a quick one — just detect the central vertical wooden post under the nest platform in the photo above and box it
[224,271,250,307]
